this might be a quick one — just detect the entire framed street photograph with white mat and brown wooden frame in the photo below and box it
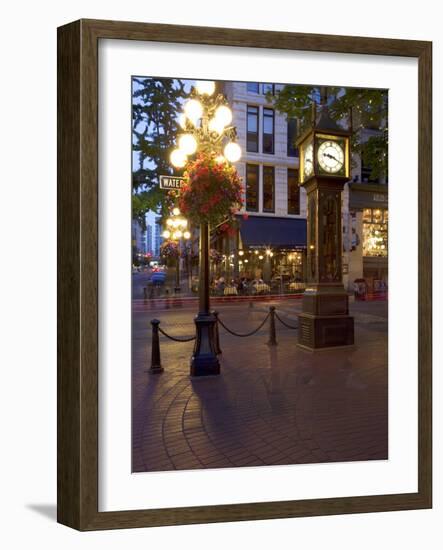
[58,20,432,530]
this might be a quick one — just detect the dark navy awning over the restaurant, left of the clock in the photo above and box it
[238,216,306,249]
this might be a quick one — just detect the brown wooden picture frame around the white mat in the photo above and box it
[58,20,432,530]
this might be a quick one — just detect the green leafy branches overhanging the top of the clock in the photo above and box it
[267,84,388,178]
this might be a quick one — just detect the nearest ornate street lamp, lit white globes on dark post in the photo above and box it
[171,81,241,376]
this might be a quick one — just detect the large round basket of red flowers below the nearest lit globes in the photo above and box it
[179,153,243,226]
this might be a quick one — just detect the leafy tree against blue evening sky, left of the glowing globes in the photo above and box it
[132,77,188,226]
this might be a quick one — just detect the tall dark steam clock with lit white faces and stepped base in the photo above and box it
[297,107,354,351]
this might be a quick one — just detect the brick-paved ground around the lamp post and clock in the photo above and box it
[133,300,388,472]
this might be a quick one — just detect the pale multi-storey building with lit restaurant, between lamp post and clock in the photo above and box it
[214,82,306,291]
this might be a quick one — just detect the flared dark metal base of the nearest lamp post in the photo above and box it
[191,313,220,376]
